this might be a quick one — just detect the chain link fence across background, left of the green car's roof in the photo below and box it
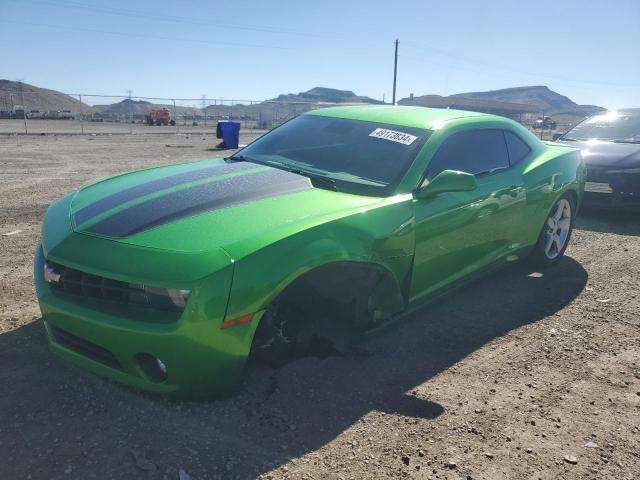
[0,90,334,134]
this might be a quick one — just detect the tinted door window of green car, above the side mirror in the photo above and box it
[426,129,509,180]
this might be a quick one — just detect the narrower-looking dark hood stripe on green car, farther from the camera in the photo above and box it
[73,162,259,225]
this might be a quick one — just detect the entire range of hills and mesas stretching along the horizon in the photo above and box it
[0,80,604,125]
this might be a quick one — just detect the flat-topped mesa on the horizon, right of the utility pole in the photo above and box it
[451,85,604,115]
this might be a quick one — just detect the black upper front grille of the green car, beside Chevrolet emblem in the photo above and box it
[45,261,183,316]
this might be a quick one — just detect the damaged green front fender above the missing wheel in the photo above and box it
[226,198,415,324]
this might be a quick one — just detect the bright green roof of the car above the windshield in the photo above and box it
[306,105,490,129]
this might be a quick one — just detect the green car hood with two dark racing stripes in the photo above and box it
[70,159,381,259]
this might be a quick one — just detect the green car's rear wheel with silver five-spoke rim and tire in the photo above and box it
[529,193,576,267]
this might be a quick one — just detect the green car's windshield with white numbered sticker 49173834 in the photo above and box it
[231,115,431,196]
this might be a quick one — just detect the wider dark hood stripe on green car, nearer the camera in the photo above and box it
[87,169,312,237]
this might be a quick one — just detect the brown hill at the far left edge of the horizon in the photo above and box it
[0,80,93,114]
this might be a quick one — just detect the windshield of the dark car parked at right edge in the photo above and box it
[563,112,640,143]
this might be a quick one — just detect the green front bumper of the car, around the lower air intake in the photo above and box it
[34,247,260,398]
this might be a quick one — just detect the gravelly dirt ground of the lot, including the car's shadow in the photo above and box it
[0,134,640,480]
